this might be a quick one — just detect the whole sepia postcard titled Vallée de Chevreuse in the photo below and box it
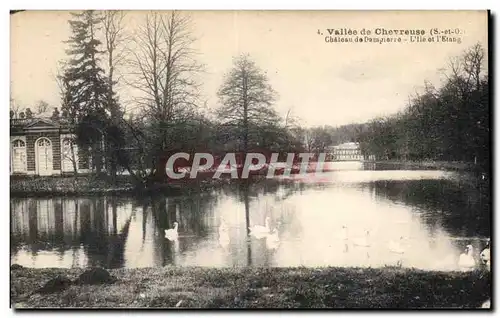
[9,10,492,310]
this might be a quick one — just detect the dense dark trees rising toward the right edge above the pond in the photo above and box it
[357,44,490,168]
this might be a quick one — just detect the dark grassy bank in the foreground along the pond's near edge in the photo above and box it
[11,267,491,308]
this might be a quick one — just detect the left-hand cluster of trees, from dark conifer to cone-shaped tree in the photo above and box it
[53,10,301,183]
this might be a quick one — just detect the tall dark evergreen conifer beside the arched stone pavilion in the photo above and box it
[62,10,112,173]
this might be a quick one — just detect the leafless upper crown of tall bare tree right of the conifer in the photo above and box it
[128,11,201,120]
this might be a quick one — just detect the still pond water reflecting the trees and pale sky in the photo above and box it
[11,163,490,270]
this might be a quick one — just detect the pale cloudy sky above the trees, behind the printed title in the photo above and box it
[10,11,488,126]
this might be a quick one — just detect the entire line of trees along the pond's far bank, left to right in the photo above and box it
[11,10,489,184]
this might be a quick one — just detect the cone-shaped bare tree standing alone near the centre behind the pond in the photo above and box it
[218,55,280,152]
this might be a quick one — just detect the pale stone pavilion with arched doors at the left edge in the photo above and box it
[10,118,91,176]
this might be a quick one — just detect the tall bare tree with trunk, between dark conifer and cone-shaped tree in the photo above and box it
[129,11,202,178]
